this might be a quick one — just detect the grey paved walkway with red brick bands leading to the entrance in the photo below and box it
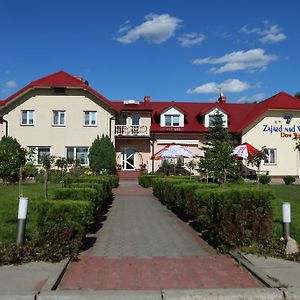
[59,182,259,290]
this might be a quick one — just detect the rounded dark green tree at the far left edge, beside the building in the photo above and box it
[0,136,26,182]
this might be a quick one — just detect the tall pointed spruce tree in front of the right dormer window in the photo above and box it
[199,113,238,184]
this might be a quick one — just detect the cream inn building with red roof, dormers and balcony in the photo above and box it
[0,71,300,177]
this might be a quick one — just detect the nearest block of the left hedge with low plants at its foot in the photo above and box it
[0,200,93,265]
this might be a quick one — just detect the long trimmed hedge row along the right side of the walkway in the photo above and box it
[153,178,273,249]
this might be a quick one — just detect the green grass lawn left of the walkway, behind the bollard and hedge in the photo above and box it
[0,184,59,243]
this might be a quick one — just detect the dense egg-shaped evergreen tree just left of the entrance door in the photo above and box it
[89,135,116,174]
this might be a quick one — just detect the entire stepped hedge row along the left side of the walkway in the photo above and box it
[0,176,118,264]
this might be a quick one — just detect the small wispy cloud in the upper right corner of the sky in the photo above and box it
[240,21,287,44]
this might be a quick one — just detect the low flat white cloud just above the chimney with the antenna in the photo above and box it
[187,79,251,94]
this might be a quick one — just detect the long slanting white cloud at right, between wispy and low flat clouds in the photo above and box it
[193,48,278,74]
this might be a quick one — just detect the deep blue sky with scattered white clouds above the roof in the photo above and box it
[0,0,300,103]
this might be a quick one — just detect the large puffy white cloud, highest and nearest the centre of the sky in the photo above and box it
[116,14,182,44]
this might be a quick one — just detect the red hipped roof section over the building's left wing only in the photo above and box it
[0,71,113,108]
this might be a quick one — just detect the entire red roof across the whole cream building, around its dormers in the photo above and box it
[0,71,300,133]
